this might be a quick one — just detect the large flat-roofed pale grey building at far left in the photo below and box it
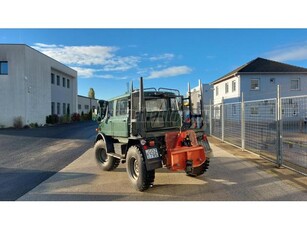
[0,44,77,127]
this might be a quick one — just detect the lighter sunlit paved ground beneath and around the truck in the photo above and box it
[19,138,307,201]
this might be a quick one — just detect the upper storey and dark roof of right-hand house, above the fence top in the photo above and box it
[211,58,307,104]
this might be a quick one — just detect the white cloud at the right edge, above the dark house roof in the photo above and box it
[266,43,307,62]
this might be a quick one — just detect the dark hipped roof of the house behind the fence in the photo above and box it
[211,57,307,84]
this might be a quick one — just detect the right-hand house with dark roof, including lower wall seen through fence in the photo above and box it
[212,58,307,122]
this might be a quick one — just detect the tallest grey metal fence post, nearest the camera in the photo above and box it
[276,85,283,167]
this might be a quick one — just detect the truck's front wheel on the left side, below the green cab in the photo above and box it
[94,140,120,171]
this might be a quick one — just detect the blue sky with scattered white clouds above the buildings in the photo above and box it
[0,29,307,99]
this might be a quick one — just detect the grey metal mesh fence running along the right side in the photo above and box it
[203,91,307,174]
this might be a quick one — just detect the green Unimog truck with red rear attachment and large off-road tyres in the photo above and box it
[94,78,211,191]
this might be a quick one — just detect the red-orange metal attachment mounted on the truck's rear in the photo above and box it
[165,130,206,171]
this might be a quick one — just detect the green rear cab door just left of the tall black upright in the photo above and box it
[112,98,129,137]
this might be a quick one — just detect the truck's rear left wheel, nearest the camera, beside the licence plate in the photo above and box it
[126,146,155,191]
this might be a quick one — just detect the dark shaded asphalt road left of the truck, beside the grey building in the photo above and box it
[0,121,97,201]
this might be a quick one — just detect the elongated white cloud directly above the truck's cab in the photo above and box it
[147,66,192,79]
